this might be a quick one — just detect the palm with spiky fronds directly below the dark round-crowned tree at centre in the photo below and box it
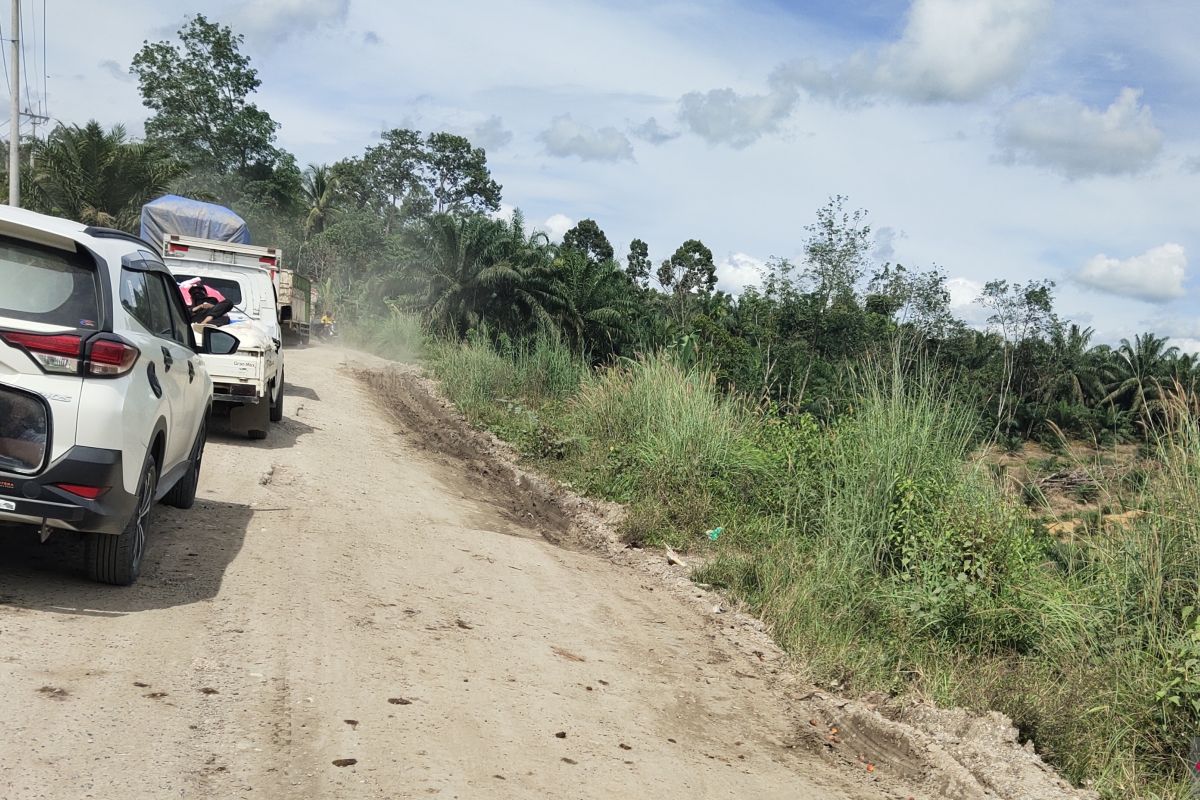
[554,248,634,357]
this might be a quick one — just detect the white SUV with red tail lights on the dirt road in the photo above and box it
[0,206,238,585]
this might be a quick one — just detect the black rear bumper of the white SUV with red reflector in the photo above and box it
[0,445,137,534]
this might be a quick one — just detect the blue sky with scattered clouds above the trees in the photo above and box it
[18,0,1200,351]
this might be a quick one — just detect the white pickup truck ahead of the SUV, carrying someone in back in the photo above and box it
[162,234,284,439]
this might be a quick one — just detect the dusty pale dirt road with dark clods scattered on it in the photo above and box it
[0,348,1080,800]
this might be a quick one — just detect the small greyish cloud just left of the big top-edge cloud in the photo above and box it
[679,84,799,149]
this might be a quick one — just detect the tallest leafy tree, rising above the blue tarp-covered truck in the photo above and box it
[130,14,278,172]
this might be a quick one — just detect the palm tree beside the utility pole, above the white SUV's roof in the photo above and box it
[29,120,185,230]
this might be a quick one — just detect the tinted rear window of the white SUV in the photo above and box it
[0,237,100,329]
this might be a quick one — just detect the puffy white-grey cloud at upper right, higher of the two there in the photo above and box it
[1000,88,1163,179]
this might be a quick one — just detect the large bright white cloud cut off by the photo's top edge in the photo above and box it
[776,0,1050,103]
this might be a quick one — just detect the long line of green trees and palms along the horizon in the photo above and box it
[4,14,1200,446]
